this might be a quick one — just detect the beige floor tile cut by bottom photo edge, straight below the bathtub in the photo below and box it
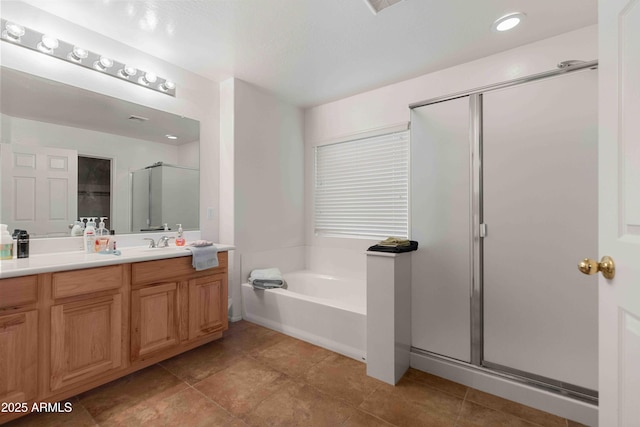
[244,380,356,427]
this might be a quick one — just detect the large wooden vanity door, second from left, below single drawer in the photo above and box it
[51,294,122,390]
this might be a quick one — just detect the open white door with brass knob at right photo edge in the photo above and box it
[600,0,640,427]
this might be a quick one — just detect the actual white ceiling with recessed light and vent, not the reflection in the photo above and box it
[25,0,597,107]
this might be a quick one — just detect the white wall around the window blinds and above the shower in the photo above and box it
[305,26,598,250]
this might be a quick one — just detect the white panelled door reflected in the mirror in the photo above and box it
[0,144,78,237]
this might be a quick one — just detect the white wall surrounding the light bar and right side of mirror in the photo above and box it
[0,1,219,241]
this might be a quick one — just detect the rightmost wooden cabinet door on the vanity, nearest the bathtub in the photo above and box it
[189,274,227,340]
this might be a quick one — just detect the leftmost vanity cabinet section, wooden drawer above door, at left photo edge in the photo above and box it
[0,276,38,406]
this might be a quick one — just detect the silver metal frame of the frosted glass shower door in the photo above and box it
[409,60,598,405]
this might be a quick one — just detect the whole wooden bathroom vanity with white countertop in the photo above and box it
[0,245,233,424]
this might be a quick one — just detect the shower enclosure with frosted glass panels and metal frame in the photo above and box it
[411,62,598,403]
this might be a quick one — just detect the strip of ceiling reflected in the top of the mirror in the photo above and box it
[0,67,200,145]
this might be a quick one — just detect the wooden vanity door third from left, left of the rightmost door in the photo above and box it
[131,282,180,360]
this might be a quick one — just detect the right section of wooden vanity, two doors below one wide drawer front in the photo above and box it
[131,252,228,362]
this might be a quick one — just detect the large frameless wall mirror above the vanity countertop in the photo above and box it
[0,67,200,238]
